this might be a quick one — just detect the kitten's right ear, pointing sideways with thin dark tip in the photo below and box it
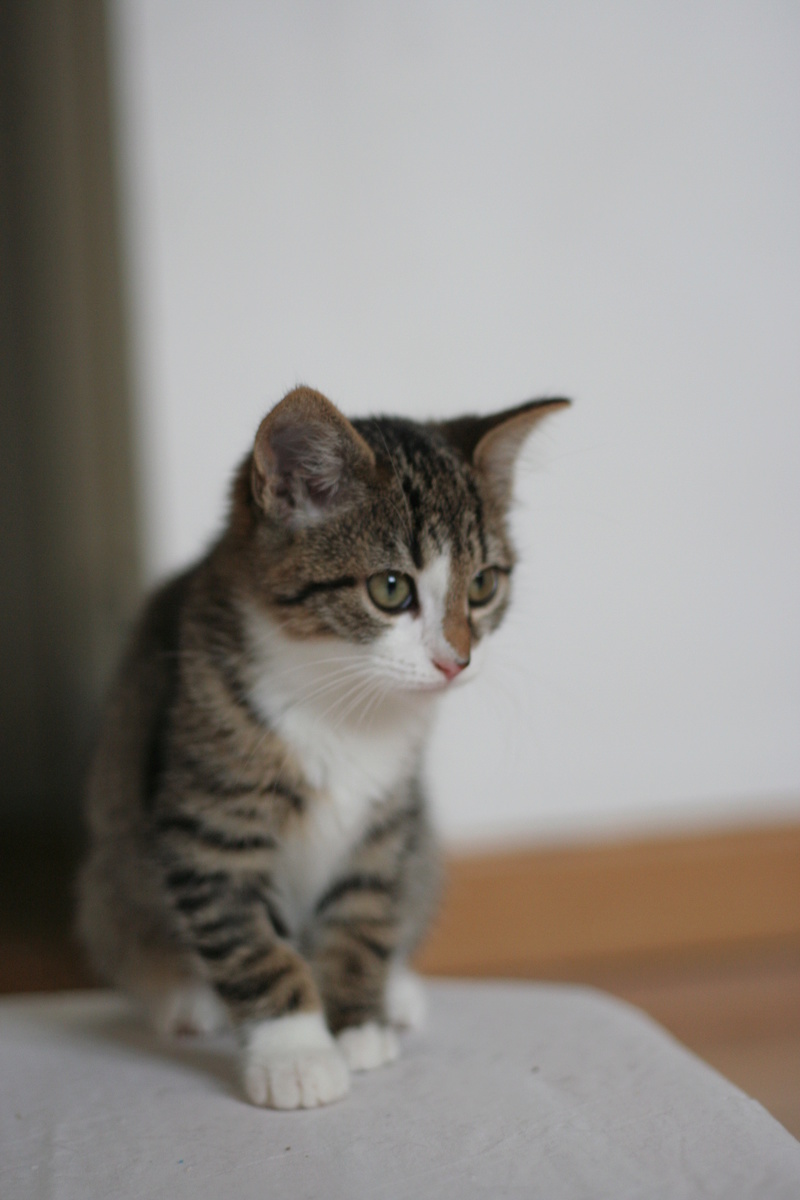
[437,396,571,505]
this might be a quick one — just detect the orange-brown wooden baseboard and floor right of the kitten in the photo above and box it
[412,823,800,1138]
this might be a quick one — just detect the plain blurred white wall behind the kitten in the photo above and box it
[114,0,800,840]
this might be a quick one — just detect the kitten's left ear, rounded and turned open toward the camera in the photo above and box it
[252,388,375,527]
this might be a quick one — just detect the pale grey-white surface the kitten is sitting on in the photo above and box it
[0,983,800,1200]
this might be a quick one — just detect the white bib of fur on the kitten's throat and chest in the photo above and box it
[251,609,431,930]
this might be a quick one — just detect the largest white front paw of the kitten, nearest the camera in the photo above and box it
[245,1013,350,1109]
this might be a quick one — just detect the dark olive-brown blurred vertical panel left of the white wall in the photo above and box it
[0,0,139,827]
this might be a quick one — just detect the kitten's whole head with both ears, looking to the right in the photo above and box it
[231,388,569,691]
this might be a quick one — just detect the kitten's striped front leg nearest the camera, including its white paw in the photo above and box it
[167,865,349,1109]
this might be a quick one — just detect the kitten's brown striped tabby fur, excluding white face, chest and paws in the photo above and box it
[73,389,565,1032]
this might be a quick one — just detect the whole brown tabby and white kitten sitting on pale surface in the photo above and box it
[79,388,567,1109]
